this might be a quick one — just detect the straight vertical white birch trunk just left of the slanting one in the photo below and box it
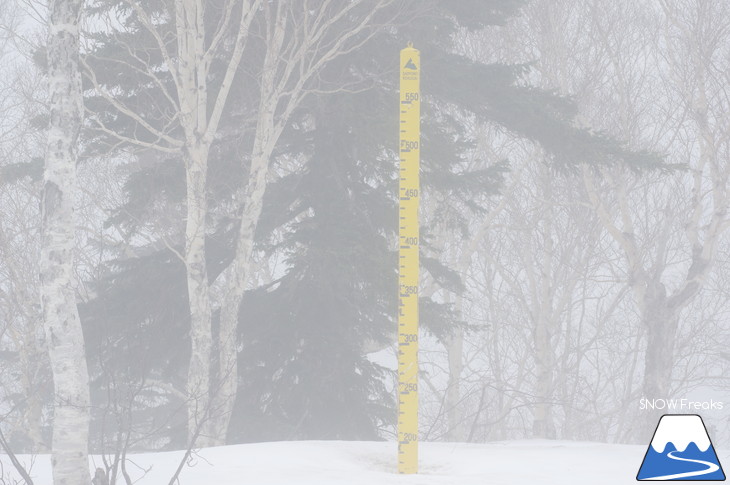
[170,0,260,446]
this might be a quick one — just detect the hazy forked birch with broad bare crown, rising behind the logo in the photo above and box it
[506,1,727,439]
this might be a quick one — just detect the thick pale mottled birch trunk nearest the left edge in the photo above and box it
[40,0,91,485]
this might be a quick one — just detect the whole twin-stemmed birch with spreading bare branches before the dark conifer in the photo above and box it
[85,0,390,445]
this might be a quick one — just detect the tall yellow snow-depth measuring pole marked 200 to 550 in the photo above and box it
[398,43,421,473]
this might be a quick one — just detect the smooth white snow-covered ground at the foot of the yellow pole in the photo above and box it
[0,441,730,485]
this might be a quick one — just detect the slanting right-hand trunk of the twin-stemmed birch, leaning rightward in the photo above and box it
[207,0,387,444]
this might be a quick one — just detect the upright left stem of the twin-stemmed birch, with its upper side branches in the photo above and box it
[130,0,261,445]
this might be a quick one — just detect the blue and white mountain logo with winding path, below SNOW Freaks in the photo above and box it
[636,414,725,481]
